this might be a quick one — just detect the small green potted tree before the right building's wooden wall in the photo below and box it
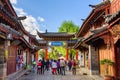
[100,59,114,80]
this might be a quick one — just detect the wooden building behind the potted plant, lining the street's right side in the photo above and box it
[74,0,120,80]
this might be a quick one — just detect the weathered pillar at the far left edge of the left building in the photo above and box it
[0,40,10,80]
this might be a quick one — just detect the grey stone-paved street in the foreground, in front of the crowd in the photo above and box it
[18,70,94,80]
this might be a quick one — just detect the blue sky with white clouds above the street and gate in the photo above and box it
[10,0,103,35]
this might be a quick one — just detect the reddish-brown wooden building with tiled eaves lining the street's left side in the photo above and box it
[0,0,39,80]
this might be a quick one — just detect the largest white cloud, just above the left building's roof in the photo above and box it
[14,7,43,38]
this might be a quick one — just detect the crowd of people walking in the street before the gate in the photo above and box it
[33,58,77,75]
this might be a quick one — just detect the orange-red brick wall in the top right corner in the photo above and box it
[111,0,120,14]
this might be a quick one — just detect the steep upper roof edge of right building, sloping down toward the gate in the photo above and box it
[77,0,110,37]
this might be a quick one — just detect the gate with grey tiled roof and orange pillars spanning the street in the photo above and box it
[37,32,78,60]
